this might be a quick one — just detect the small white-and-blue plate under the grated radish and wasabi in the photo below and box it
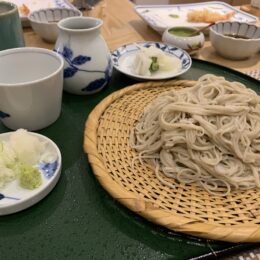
[0,132,61,215]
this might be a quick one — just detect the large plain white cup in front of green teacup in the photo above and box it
[0,47,64,131]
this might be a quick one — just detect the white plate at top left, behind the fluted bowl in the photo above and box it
[9,0,76,25]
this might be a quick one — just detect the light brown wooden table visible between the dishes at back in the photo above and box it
[24,0,260,75]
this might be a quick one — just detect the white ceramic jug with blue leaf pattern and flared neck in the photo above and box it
[54,17,113,95]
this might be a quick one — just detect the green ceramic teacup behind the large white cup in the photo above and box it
[0,1,24,50]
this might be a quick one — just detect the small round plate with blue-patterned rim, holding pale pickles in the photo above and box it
[112,42,192,80]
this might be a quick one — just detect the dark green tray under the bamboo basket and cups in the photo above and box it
[0,60,260,260]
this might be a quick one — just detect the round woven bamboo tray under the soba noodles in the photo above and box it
[84,80,260,242]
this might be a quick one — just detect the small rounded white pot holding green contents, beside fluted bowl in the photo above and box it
[162,26,205,55]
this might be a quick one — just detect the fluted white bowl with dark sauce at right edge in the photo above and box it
[209,21,260,60]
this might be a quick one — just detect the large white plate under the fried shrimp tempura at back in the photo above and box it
[135,1,258,33]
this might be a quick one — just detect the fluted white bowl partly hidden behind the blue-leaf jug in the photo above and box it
[28,8,82,43]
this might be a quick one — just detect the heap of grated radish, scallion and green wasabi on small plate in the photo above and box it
[0,129,56,190]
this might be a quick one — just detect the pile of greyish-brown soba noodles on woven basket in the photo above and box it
[130,75,260,196]
